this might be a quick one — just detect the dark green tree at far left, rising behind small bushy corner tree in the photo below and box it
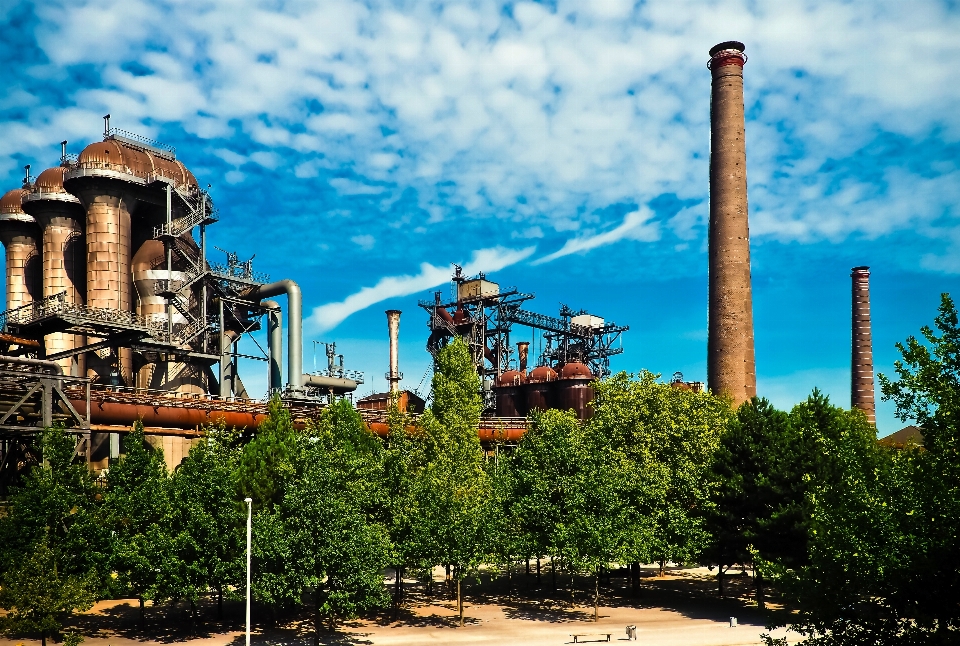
[0,427,113,594]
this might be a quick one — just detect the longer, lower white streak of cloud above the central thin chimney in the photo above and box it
[308,247,536,331]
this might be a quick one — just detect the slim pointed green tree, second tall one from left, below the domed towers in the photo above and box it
[106,422,179,626]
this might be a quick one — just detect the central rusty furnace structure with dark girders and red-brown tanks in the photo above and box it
[419,266,630,419]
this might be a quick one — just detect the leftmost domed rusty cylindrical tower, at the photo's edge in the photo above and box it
[0,188,43,310]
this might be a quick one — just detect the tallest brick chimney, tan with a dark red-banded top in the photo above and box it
[707,41,757,406]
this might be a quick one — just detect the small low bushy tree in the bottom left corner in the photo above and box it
[0,539,97,646]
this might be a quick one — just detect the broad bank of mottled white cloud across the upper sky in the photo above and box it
[7,0,960,266]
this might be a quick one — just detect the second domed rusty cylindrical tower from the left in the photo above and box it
[23,166,87,376]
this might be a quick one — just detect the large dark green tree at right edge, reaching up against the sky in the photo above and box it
[774,294,960,646]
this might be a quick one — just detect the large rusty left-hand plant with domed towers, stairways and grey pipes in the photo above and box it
[0,115,362,479]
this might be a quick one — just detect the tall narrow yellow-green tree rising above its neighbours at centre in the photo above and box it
[416,338,490,626]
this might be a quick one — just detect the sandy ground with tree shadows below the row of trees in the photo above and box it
[0,570,798,646]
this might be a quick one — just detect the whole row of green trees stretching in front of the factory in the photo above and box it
[0,295,960,644]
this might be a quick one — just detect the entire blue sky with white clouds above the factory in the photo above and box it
[0,0,960,435]
